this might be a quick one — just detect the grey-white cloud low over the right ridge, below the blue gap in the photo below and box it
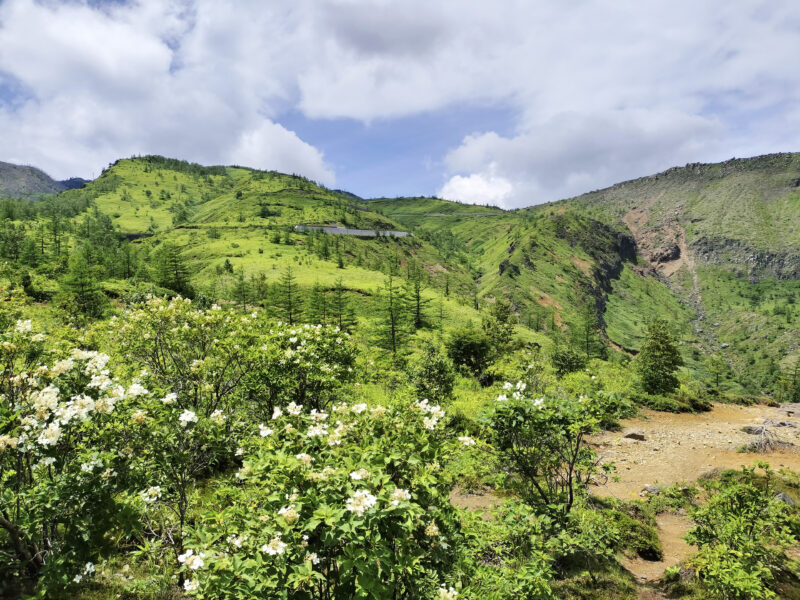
[443,111,721,207]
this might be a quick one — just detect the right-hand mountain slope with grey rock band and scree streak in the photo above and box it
[552,154,800,390]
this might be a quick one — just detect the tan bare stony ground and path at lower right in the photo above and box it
[591,404,800,598]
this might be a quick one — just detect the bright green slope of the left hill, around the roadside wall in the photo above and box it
[70,159,496,336]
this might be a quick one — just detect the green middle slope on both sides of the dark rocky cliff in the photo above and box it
[369,198,693,350]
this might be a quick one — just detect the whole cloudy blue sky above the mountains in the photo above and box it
[0,0,800,208]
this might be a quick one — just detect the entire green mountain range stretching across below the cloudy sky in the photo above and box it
[15,154,800,394]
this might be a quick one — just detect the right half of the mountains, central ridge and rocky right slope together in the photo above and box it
[368,154,800,392]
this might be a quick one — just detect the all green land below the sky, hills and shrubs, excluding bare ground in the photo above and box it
[0,156,800,600]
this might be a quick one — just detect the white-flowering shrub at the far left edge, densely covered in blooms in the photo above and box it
[0,321,135,590]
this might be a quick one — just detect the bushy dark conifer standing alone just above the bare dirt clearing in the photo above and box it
[636,319,683,394]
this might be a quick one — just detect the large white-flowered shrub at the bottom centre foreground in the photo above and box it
[177,401,460,599]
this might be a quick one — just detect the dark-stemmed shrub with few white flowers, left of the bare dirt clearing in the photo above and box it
[487,382,603,516]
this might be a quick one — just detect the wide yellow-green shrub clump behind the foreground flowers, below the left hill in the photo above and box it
[111,298,355,418]
